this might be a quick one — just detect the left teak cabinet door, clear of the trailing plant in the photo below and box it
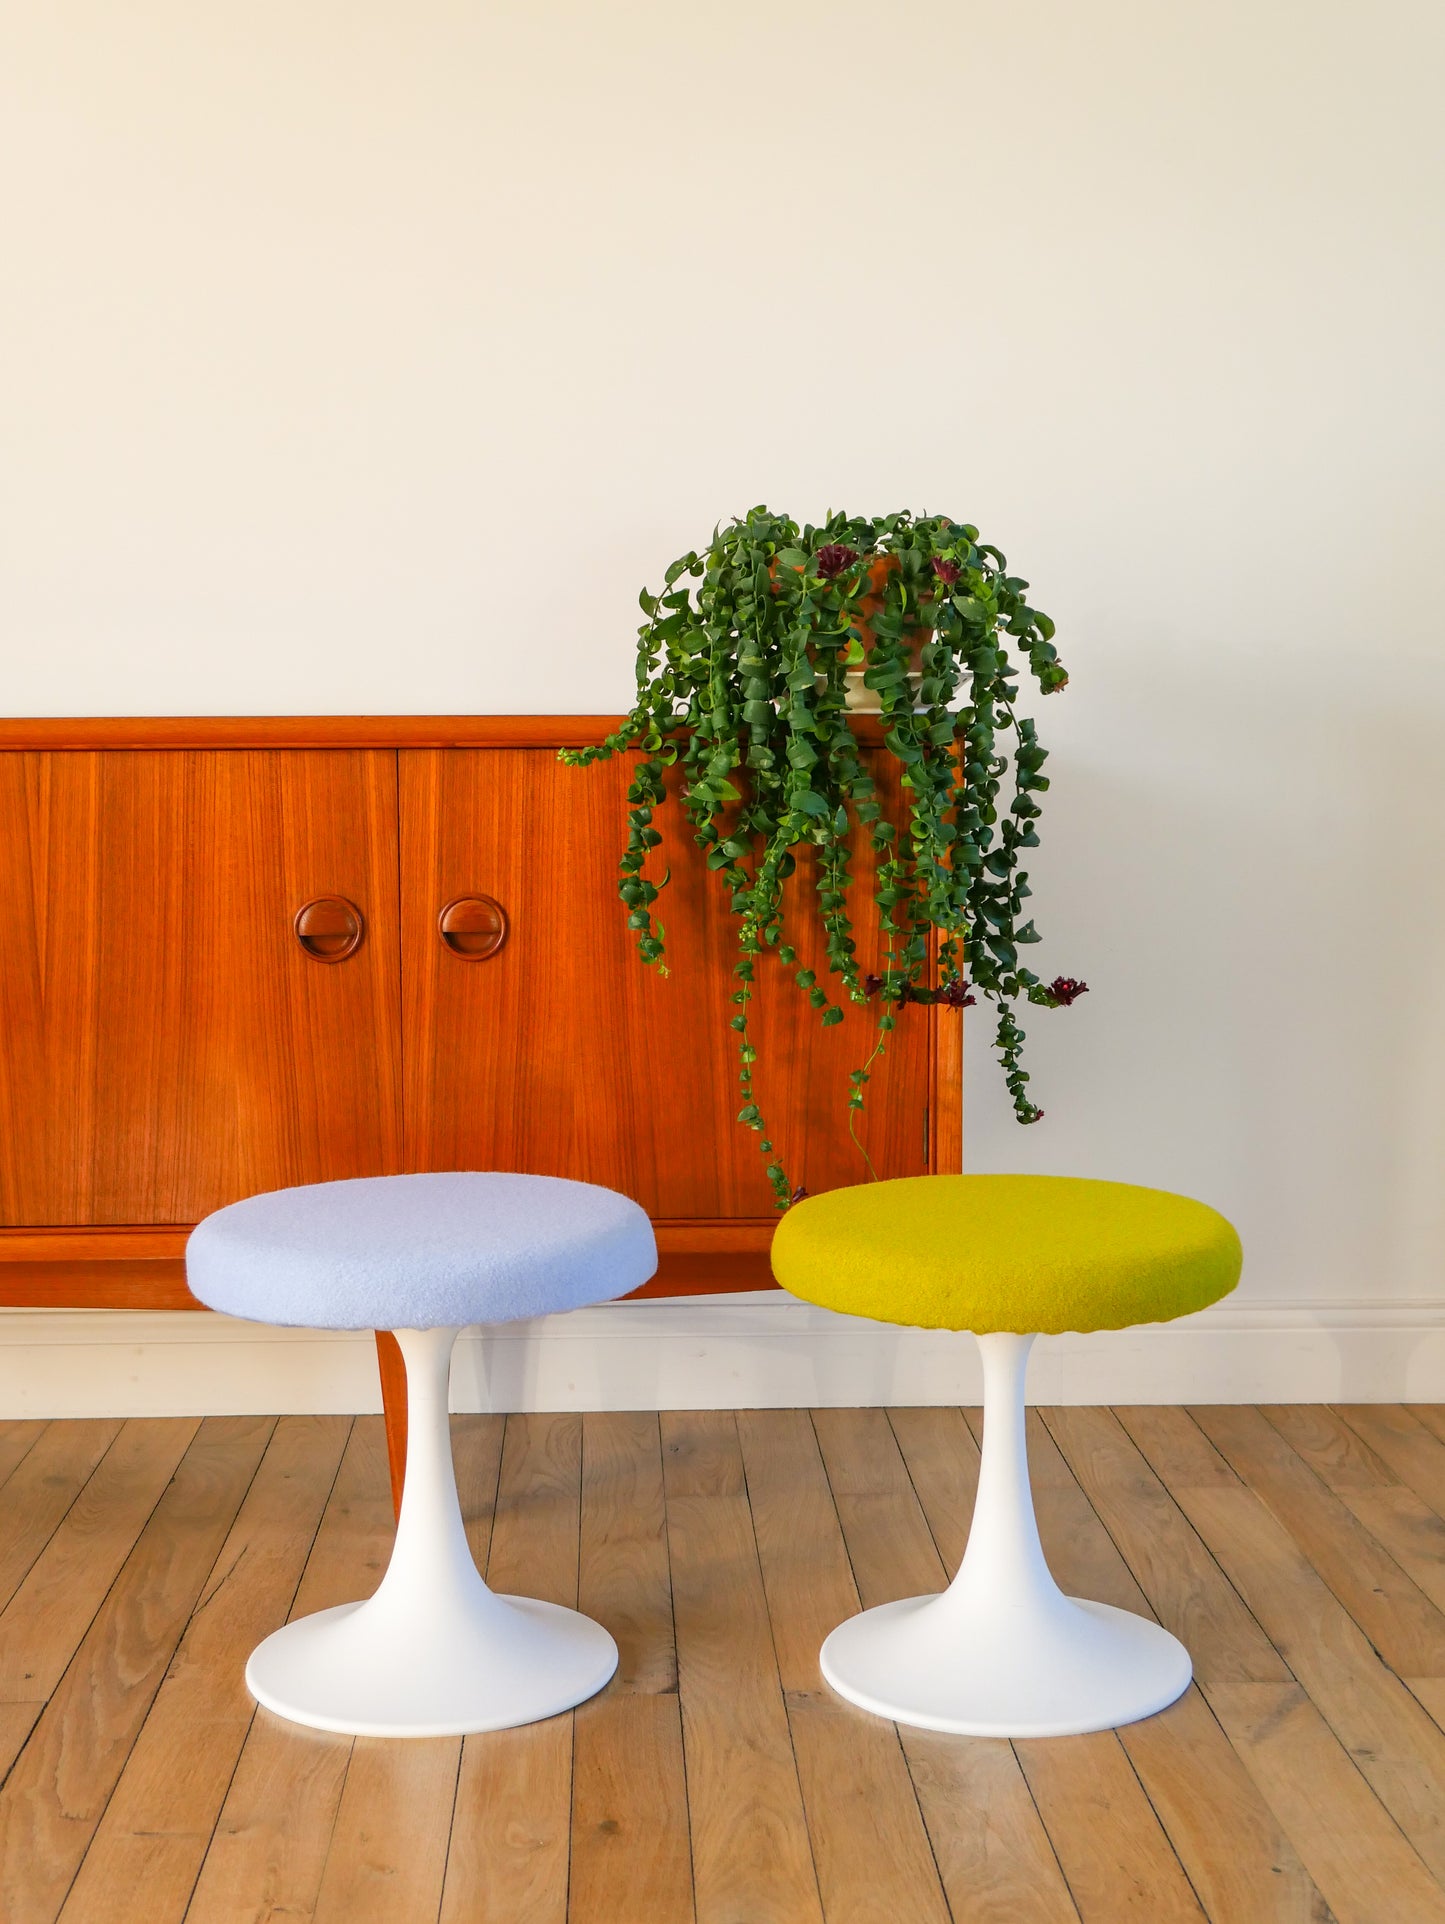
[0,750,400,1224]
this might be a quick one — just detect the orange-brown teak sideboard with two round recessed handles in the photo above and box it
[0,716,962,1493]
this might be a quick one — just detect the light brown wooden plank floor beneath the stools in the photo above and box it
[0,1406,1445,1924]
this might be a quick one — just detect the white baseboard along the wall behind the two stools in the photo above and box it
[0,1291,1445,1416]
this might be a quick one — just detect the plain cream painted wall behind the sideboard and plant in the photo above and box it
[0,0,1445,1301]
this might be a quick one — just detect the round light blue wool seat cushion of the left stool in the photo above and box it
[185,1172,658,1329]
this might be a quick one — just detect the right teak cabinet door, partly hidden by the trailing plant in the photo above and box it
[400,748,938,1222]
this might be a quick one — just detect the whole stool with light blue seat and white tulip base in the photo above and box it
[187,1174,658,1737]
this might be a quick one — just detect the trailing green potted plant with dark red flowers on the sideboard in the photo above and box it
[562,508,1087,1208]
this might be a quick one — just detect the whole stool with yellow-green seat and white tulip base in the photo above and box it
[773,1176,1241,1737]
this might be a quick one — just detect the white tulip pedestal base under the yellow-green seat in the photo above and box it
[820,1333,1193,1737]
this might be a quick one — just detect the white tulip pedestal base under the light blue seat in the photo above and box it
[246,1329,618,1737]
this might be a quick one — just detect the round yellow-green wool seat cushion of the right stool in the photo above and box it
[772,1176,1243,1335]
